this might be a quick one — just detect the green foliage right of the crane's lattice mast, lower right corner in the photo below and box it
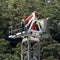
[41,38,60,60]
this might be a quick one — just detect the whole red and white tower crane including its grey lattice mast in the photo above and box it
[8,11,48,60]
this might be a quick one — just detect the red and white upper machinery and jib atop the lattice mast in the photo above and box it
[8,11,48,39]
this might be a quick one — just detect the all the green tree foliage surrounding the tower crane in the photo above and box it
[0,0,60,60]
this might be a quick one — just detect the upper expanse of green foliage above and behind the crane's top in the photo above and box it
[0,0,60,40]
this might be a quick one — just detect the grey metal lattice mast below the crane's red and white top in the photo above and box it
[21,35,40,60]
